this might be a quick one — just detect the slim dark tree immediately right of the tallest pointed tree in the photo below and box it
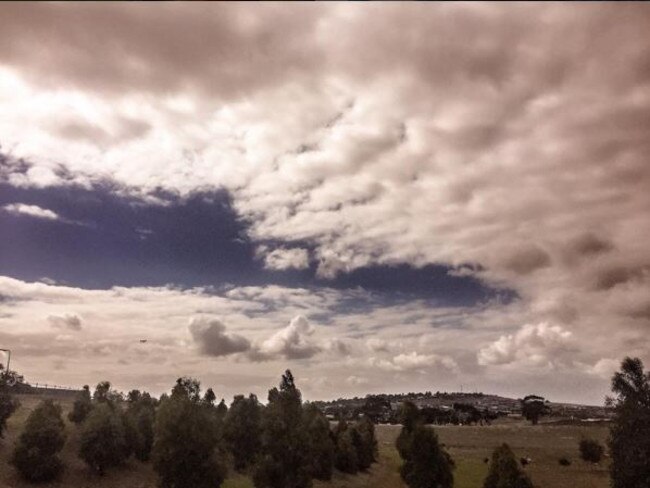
[303,403,334,481]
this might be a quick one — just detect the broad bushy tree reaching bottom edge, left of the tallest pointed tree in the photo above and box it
[152,378,226,488]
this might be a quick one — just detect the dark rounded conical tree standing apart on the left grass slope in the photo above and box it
[11,400,65,482]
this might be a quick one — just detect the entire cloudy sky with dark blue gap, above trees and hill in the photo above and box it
[0,2,650,404]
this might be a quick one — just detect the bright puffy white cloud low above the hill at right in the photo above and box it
[477,323,575,366]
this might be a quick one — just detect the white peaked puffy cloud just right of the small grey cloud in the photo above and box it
[251,315,321,360]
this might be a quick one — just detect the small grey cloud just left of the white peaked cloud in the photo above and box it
[188,317,251,357]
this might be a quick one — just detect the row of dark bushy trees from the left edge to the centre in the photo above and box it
[0,370,377,488]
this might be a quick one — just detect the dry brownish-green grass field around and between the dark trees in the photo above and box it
[0,397,609,488]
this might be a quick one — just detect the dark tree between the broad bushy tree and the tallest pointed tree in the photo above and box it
[224,393,262,471]
